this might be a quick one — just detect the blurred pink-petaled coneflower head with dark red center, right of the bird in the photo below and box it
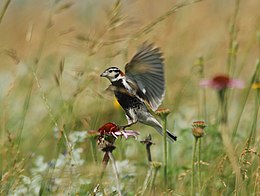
[200,75,244,90]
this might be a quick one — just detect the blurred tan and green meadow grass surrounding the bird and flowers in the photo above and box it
[0,0,260,195]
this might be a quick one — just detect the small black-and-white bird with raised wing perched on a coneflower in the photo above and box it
[100,43,177,141]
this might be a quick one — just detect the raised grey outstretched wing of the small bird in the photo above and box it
[125,43,165,111]
